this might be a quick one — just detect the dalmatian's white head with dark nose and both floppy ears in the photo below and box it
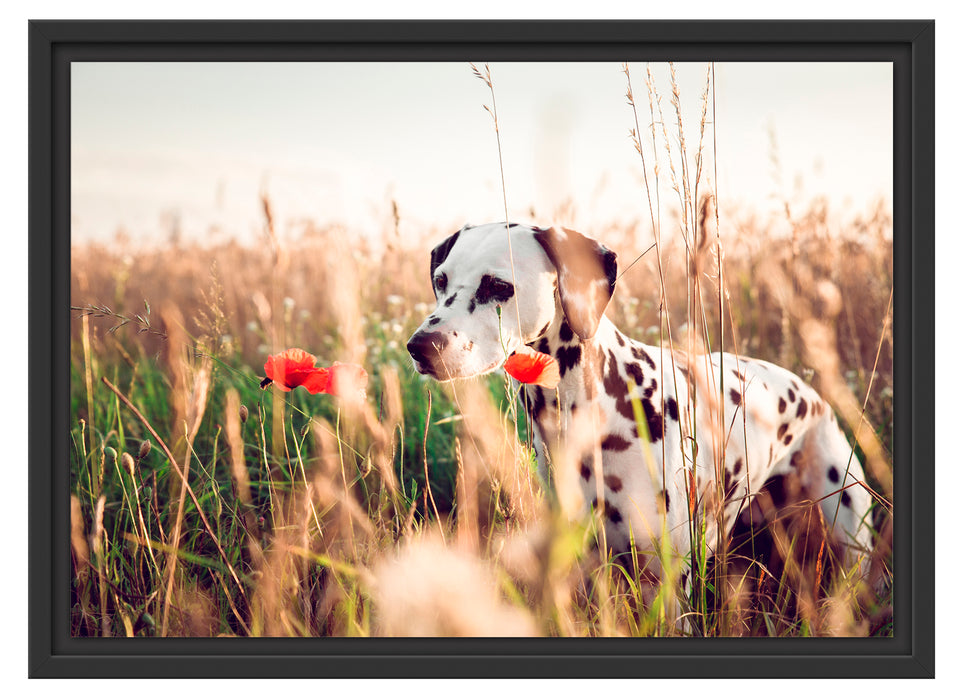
[406,223,616,381]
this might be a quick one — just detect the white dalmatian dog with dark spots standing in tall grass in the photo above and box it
[407,223,873,570]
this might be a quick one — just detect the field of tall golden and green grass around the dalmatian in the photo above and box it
[70,65,893,636]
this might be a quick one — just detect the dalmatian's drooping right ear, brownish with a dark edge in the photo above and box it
[533,227,616,339]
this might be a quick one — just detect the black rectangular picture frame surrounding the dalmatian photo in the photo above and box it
[28,21,935,678]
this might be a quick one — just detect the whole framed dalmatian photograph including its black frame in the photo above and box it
[29,21,934,677]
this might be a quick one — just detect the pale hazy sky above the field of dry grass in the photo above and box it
[71,63,893,243]
